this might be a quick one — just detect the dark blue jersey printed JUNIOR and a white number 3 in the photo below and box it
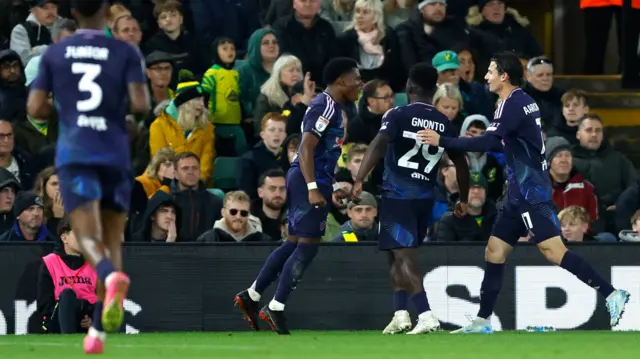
[32,29,146,169]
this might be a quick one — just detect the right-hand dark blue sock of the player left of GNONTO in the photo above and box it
[274,243,318,303]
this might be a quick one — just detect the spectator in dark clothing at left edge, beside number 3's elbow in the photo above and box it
[0,50,28,120]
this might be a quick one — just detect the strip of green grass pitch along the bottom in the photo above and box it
[0,331,640,359]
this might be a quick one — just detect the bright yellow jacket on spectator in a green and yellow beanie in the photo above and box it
[149,111,216,184]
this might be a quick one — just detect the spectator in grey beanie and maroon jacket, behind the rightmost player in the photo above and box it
[545,137,604,232]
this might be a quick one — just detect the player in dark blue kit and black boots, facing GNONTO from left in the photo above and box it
[234,58,362,334]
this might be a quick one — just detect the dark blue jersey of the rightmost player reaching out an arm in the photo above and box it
[485,88,552,205]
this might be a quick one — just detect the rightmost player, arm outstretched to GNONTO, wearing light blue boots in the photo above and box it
[419,52,629,333]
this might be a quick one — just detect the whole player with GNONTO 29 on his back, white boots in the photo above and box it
[351,63,469,334]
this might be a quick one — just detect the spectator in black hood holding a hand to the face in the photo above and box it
[132,191,182,243]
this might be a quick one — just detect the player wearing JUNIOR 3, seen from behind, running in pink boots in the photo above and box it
[27,0,150,354]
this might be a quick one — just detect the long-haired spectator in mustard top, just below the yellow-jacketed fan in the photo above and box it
[136,147,176,198]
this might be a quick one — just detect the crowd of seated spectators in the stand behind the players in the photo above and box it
[0,0,640,248]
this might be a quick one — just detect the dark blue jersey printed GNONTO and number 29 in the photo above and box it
[379,102,457,199]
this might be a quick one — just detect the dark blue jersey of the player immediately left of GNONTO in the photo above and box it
[291,92,344,183]
